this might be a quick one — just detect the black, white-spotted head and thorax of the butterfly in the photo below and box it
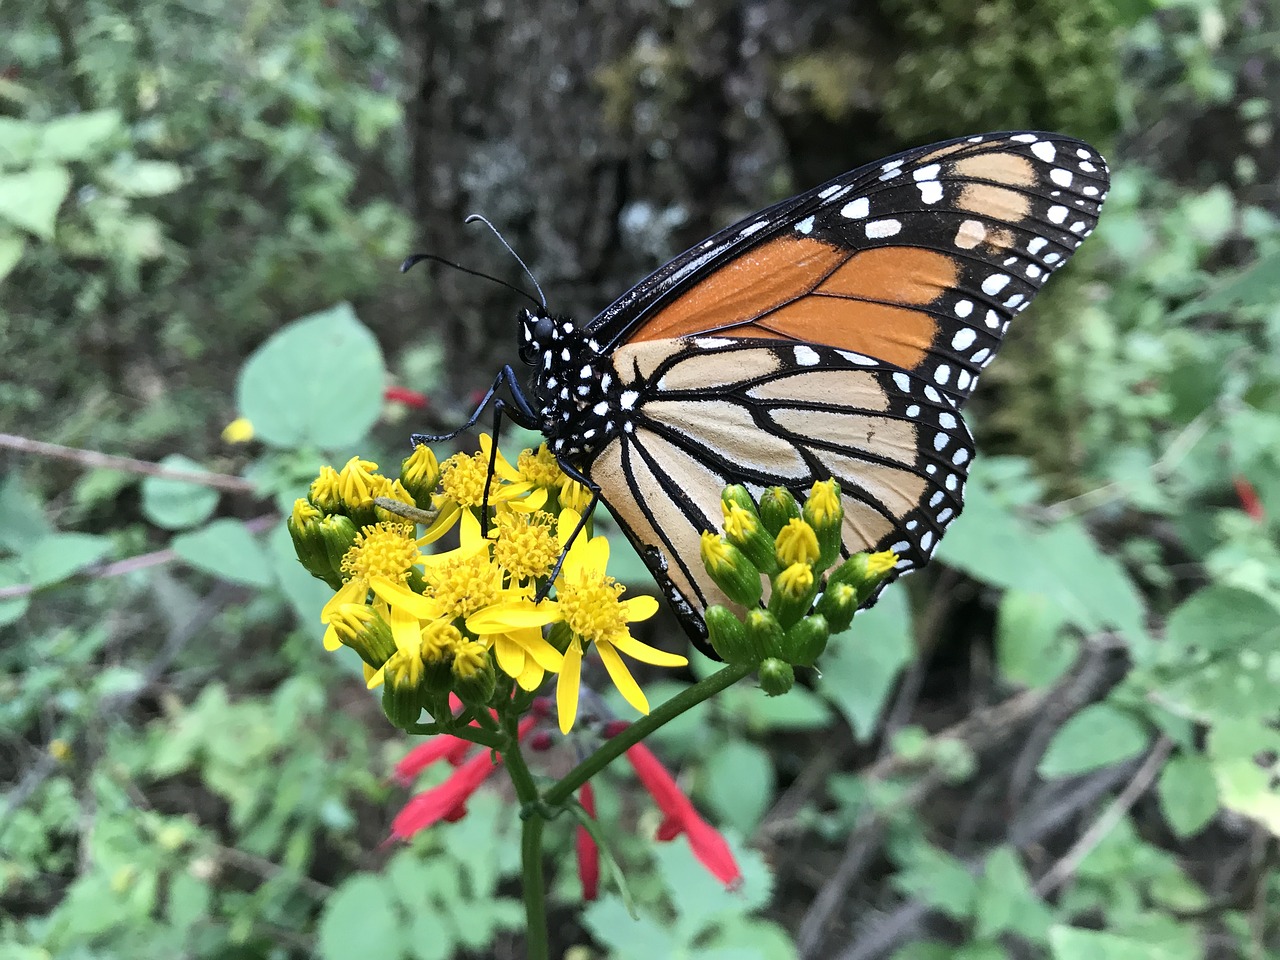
[520,310,622,466]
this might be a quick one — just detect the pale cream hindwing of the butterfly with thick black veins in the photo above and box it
[588,338,973,649]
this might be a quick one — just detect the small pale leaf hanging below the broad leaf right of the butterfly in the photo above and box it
[996,590,1079,687]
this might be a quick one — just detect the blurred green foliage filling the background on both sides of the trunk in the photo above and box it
[0,0,1280,960]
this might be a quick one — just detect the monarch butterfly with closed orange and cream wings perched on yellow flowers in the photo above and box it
[413,132,1108,655]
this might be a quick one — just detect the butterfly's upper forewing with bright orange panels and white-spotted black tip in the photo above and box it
[589,132,1108,403]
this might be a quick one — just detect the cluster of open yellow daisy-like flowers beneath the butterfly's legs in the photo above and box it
[288,435,686,732]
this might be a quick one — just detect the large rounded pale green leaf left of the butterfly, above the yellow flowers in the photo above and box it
[237,303,385,449]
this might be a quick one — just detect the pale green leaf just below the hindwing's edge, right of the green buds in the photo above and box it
[818,588,914,740]
